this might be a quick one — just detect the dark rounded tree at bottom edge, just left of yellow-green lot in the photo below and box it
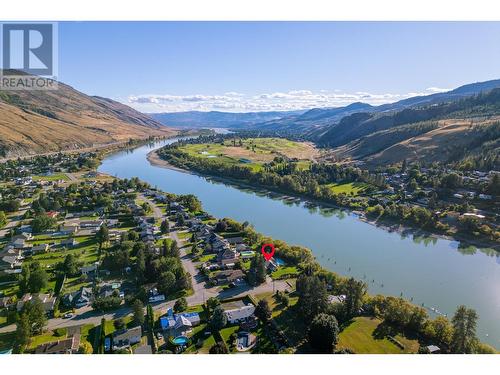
[309,314,339,353]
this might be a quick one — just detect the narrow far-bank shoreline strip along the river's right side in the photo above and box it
[146,150,500,252]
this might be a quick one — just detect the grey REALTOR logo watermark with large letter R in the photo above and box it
[0,22,58,90]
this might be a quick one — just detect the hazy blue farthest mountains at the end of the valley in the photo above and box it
[149,110,305,128]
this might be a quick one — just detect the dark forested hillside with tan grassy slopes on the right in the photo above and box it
[328,89,500,167]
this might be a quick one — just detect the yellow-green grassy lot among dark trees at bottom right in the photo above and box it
[337,317,419,354]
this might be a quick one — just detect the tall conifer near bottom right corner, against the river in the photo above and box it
[451,305,478,354]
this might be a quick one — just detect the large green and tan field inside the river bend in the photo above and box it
[180,138,320,170]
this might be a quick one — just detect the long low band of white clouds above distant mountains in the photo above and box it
[122,87,448,112]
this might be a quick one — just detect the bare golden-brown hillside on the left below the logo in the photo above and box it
[0,72,174,157]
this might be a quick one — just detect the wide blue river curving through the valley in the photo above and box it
[99,134,500,348]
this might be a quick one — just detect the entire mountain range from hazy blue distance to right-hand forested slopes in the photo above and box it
[153,80,500,167]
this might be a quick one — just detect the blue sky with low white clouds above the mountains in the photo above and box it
[58,22,500,112]
